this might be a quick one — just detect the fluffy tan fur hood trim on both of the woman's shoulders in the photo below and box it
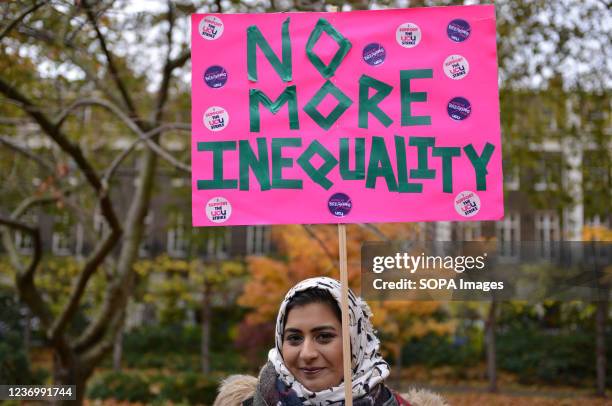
[213,375,448,406]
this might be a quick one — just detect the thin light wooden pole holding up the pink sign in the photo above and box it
[338,224,353,406]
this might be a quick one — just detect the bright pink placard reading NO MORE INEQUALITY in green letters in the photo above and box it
[191,6,504,226]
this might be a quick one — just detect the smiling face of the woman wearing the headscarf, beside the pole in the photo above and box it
[282,303,344,392]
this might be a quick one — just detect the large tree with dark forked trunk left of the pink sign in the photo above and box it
[0,1,195,404]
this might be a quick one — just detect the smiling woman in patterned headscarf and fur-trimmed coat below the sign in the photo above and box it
[213,278,446,406]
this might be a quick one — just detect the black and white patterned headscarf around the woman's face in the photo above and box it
[268,277,389,406]
